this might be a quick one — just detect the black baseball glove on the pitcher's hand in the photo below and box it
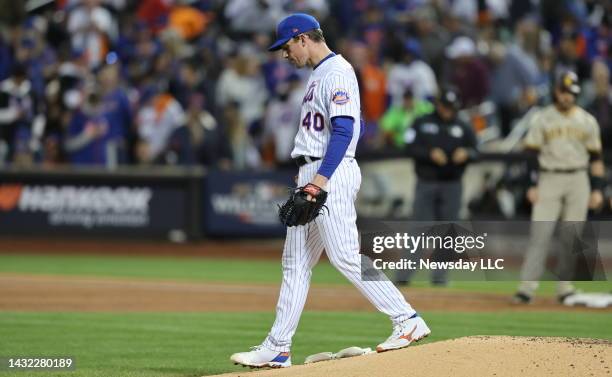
[278,183,327,226]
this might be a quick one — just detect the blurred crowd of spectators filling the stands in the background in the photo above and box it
[0,0,612,169]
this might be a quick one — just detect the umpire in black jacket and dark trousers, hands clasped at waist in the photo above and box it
[396,88,477,285]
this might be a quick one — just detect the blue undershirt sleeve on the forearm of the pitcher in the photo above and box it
[317,116,354,179]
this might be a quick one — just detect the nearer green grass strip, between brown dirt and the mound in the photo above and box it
[0,312,612,377]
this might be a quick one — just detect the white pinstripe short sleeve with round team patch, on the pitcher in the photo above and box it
[323,72,360,120]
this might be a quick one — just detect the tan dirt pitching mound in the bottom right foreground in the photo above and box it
[212,336,612,377]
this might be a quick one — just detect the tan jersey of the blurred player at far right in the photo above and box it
[525,105,601,169]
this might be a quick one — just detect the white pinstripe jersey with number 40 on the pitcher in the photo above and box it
[291,55,361,158]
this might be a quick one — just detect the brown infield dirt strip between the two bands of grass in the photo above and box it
[0,273,612,312]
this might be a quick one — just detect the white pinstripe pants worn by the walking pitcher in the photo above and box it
[263,158,415,352]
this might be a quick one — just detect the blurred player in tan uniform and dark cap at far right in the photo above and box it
[513,72,605,303]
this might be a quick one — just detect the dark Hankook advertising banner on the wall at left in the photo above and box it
[0,167,199,241]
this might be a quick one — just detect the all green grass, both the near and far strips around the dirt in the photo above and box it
[0,254,612,377]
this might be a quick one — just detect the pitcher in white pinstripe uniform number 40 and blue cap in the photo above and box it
[231,13,430,367]
